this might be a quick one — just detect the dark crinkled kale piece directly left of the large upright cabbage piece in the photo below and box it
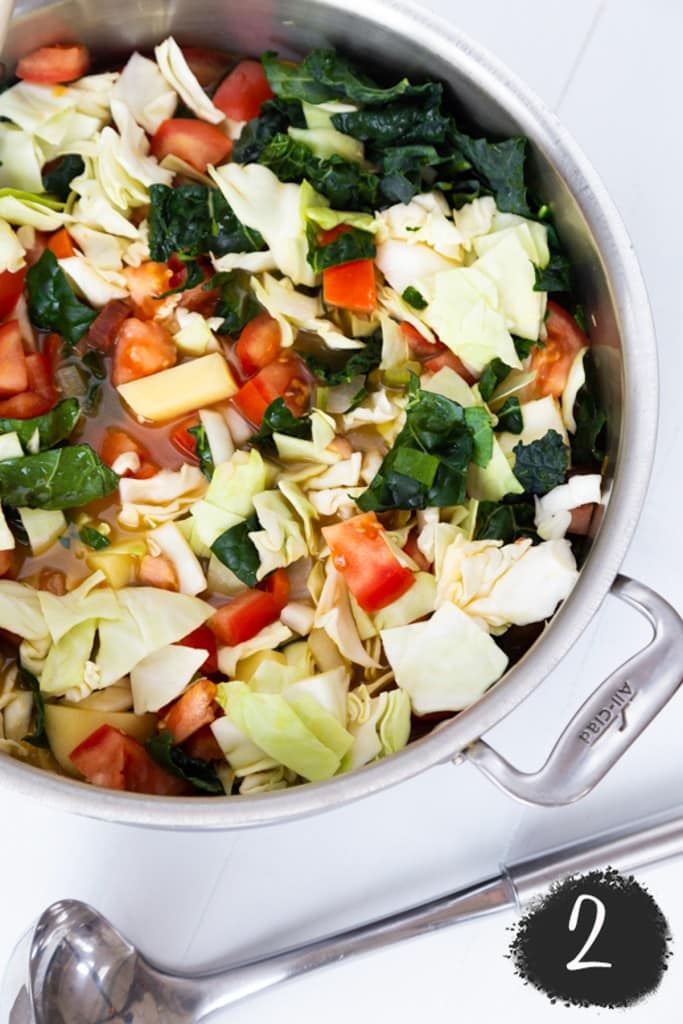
[148,182,265,262]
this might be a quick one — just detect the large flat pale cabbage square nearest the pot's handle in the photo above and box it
[381,604,508,715]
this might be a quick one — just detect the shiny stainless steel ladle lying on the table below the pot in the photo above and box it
[5,807,683,1024]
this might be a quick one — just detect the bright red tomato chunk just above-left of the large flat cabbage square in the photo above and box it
[323,512,415,611]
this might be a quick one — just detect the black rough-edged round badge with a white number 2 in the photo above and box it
[510,868,671,1007]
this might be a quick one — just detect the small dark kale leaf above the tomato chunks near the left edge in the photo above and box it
[26,249,97,345]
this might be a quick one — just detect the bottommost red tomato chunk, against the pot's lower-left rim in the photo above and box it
[70,725,191,797]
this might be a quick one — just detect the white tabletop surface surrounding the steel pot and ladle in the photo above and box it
[0,0,683,1024]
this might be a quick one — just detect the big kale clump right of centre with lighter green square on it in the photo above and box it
[356,389,493,512]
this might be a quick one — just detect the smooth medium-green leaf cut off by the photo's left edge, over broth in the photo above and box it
[0,444,119,510]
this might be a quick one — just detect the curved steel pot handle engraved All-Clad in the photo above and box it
[455,575,683,807]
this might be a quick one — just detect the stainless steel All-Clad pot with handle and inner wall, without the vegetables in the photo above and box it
[0,0,683,829]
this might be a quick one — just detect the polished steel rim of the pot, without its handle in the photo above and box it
[0,0,657,831]
